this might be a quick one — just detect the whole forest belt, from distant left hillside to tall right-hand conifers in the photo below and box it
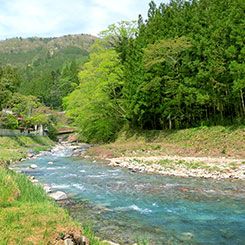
[0,0,245,142]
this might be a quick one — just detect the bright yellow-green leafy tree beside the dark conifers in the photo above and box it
[64,41,124,142]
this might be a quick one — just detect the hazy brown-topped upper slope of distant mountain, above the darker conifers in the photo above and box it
[0,34,96,68]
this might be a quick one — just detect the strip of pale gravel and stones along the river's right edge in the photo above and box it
[106,156,245,179]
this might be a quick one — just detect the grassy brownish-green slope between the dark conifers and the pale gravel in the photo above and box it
[88,126,245,158]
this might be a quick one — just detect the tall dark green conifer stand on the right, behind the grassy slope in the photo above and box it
[121,0,245,129]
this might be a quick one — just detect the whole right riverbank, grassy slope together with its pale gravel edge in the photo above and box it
[85,126,245,179]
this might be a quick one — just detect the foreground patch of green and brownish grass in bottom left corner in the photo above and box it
[0,168,81,244]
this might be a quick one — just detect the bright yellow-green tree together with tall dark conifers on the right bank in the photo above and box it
[65,0,245,141]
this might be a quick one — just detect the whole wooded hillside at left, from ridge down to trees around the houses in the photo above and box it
[0,35,96,137]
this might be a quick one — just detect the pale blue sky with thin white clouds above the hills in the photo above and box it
[0,0,168,40]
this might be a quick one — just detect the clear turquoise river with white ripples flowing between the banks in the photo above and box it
[12,146,245,245]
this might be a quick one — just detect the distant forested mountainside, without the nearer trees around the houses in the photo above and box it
[0,35,96,108]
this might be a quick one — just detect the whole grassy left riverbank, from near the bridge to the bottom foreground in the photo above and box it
[0,136,106,245]
